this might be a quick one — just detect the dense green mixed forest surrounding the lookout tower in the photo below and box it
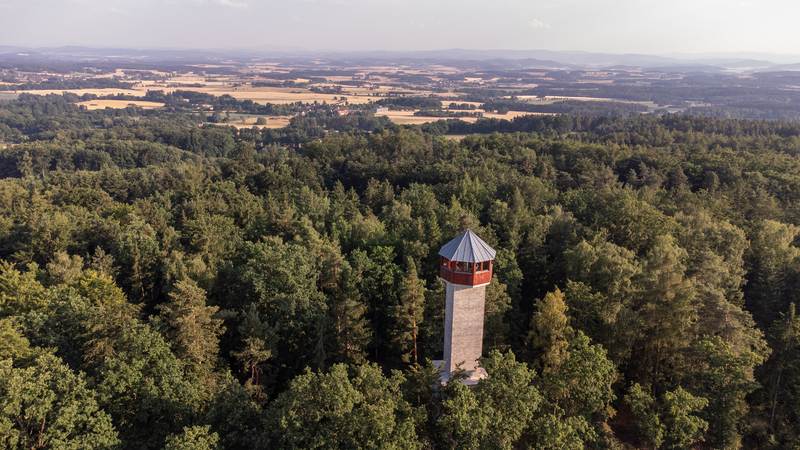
[0,94,800,449]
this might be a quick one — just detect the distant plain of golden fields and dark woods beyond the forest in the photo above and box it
[6,52,800,120]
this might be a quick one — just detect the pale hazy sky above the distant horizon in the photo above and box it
[0,0,800,54]
